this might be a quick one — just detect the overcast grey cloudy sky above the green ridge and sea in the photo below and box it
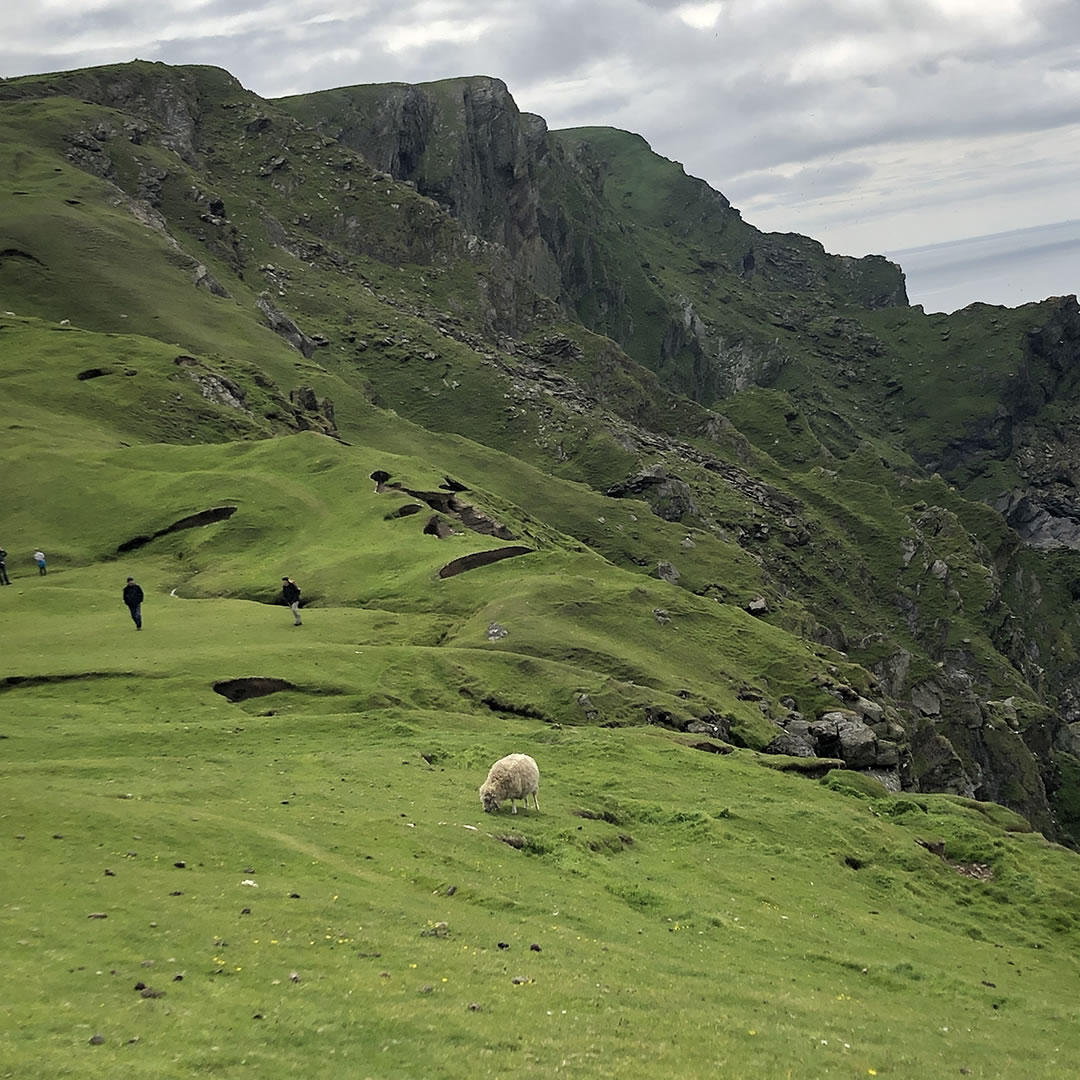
[0,0,1080,304]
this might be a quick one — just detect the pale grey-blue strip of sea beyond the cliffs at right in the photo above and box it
[886,219,1080,312]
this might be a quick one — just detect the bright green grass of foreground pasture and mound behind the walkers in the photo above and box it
[0,416,1080,1077]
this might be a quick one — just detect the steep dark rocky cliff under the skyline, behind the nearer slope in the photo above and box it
[278,77,907,403]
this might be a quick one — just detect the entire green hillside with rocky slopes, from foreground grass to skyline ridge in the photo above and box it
[0,63,1080,1080]
